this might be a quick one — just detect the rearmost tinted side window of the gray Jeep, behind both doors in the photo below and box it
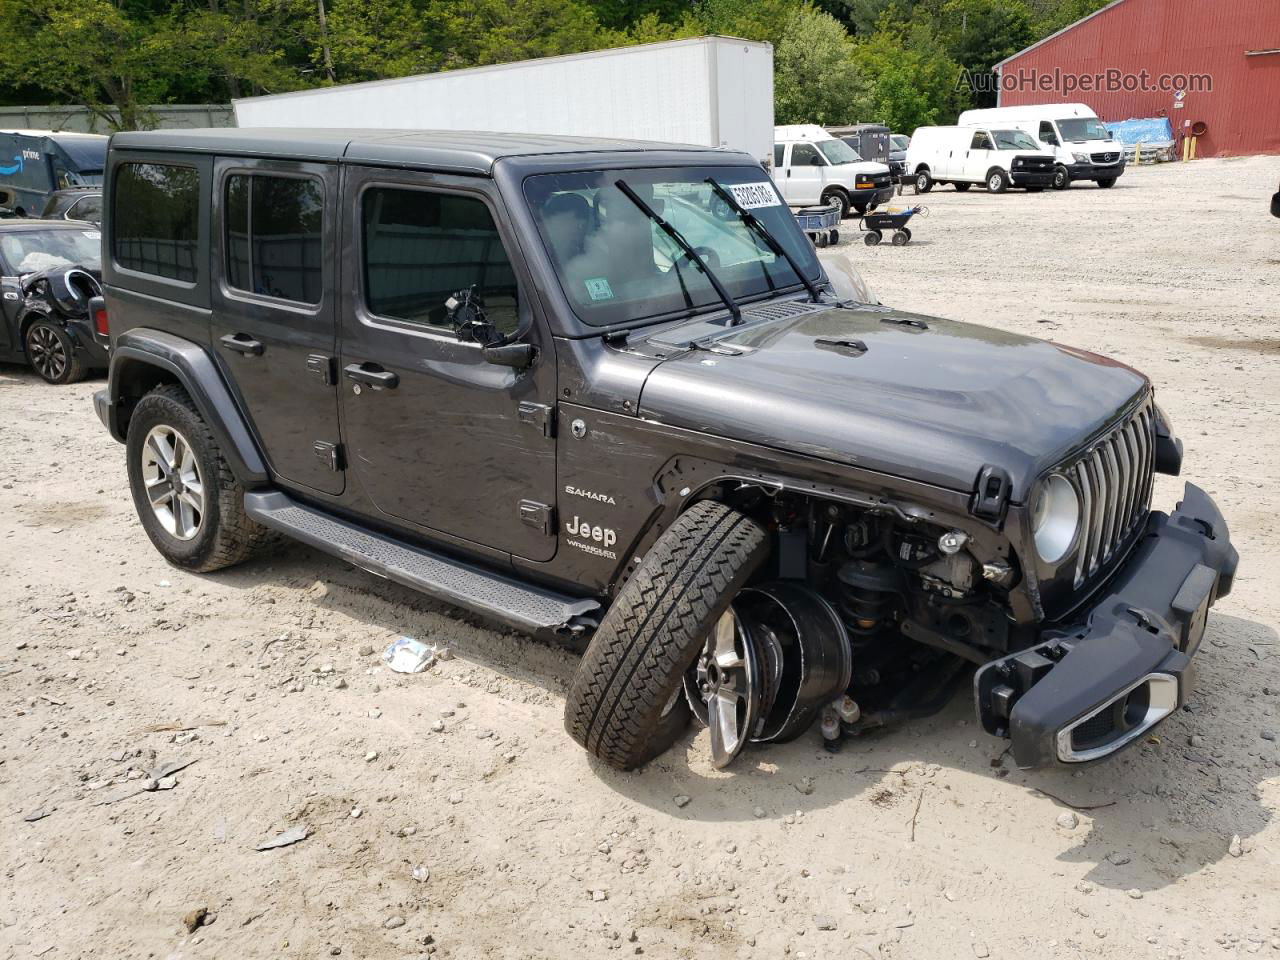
[113,164,200,283]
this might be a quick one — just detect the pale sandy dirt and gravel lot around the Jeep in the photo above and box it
[0,157,1280,960]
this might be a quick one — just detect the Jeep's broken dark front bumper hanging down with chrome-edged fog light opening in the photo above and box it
[974,484,1239,768]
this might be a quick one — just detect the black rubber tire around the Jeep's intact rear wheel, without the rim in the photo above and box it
[124,384,275,573]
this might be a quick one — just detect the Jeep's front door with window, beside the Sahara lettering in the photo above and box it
[340,168,556,561]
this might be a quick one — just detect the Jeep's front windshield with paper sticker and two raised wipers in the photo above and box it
[525,166,819,326]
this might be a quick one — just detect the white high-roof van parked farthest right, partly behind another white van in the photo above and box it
[960,104,1124,189]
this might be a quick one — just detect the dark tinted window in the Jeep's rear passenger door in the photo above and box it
[223,174,324,305]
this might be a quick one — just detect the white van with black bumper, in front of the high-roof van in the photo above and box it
[906,127,1053,193]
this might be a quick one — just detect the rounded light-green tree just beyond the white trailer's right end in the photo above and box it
[773,6,872,125]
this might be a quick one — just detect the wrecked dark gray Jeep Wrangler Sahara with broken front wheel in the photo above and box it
[95,129,1236,768]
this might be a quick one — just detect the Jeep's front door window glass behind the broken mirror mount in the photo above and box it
[361,187,520,335]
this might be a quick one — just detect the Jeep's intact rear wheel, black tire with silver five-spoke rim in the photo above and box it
[124,384,274,573]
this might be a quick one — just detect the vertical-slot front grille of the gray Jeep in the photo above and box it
[1065,403,1156,586]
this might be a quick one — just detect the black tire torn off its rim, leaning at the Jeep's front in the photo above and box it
[564,500,769,771]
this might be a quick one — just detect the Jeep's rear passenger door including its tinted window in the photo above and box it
[211,159,346,494]
